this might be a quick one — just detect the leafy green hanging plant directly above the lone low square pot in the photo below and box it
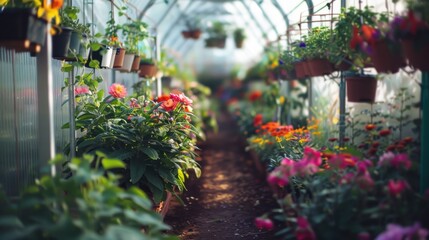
[329,6,379,70]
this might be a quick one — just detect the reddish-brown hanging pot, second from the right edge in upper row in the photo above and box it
[370,39,406,73]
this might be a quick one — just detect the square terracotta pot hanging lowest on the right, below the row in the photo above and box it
[346,75,377,103]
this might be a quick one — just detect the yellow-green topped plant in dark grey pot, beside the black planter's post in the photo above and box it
[56,6,90,61]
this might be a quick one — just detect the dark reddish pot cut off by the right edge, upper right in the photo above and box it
[401,37,429,71]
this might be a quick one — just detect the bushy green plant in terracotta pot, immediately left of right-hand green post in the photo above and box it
[305,27,334,77]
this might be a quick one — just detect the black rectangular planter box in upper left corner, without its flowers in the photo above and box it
[0,8,48,53]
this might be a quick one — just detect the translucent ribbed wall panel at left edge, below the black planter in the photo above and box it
[0,48,40,195]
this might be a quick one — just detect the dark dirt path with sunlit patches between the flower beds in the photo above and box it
[165,114,276,240]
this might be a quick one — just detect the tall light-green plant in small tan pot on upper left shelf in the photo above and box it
[120,21,148,72]
